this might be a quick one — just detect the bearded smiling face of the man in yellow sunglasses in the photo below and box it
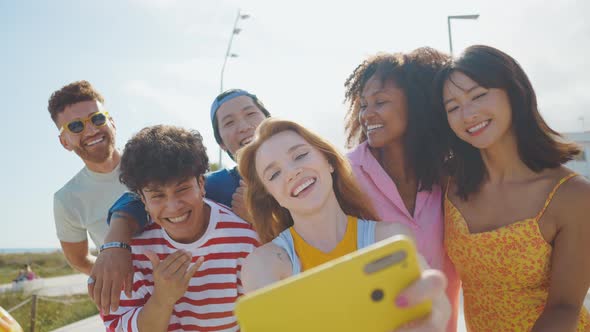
[56,100,116,163]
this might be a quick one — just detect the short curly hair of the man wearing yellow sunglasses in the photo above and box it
[47,81,104,122]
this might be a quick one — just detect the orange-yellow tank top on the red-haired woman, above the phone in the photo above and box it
[289,216,357,272]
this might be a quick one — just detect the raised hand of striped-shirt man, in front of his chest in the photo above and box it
[145,250,205,306]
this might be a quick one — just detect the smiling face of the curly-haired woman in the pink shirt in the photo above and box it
[359,75,408,148]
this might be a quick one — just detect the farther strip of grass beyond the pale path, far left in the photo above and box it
[0,251,89,284]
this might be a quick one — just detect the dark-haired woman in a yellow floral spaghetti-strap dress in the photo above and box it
[436,46,590,332]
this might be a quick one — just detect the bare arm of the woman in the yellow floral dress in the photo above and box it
[532,178,590,332]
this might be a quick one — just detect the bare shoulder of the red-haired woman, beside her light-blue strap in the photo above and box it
[242,243,292,293]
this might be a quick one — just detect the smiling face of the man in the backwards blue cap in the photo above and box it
[215,96,265,155]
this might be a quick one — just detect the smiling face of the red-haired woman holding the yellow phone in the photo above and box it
[256,130,334,214]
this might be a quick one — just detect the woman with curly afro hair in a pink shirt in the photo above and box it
[345,47,459,331]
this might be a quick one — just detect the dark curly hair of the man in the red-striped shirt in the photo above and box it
[119,125,209,194]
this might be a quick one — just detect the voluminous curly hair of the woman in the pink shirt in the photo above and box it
[344,47,450,191]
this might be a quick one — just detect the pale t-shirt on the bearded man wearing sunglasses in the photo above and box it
[53,166,127,248]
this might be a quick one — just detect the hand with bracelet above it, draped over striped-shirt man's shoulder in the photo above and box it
[88,248,133,315]
